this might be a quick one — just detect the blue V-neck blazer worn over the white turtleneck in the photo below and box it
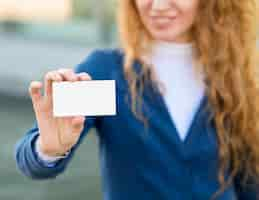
[15,48,257,200]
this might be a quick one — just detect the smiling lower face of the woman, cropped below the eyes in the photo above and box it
[135,0,199,43]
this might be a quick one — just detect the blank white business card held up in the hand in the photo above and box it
[52,80,116,117]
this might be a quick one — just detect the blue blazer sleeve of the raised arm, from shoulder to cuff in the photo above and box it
[14,50,107,179]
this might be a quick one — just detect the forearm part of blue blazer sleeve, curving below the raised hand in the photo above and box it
[15,115,95,179]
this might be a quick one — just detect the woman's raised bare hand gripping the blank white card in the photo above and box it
[29,68,91,156]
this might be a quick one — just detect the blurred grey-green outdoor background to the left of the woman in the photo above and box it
[0,0,259,200]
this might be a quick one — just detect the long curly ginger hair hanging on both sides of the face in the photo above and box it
[117,0,259,198]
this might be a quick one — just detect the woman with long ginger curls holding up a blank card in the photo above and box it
[15,0,259,200]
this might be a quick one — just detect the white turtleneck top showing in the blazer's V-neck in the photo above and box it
[150,41,205,140]
